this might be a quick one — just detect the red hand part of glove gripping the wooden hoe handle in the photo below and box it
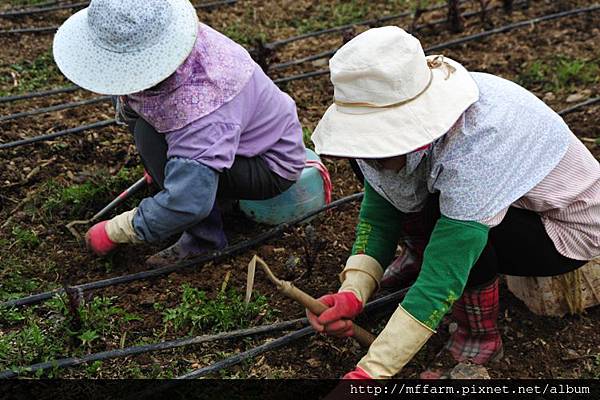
[306,292,363,337]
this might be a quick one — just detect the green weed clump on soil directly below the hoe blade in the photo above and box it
[163,285,274,334]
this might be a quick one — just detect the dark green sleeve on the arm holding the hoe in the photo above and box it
[352,180,404,268]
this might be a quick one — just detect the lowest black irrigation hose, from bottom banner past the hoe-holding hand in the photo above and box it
[175,289,408,380]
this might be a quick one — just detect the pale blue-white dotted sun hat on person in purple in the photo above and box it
[53,0,198,95]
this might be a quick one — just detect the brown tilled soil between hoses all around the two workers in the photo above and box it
[0,0,600,378]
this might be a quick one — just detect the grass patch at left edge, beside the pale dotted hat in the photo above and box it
[0,51,63,96]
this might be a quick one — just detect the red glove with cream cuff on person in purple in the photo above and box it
[85,209,142,256]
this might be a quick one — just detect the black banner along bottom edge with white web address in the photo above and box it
[0,379,600,400]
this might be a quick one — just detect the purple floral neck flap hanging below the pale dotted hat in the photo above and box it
[127,24,256,133]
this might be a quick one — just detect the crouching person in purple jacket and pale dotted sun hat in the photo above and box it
[54,0,306,266]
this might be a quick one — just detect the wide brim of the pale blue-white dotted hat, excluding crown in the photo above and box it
[53,0,198,95]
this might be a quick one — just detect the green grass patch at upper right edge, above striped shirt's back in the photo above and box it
[517,56,600,92]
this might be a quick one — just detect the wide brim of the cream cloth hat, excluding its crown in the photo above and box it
[311,56,479,158]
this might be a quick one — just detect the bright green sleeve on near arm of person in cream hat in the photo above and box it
[402,216,489,330]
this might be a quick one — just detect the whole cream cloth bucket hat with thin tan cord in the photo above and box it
[312,26,479,158]
